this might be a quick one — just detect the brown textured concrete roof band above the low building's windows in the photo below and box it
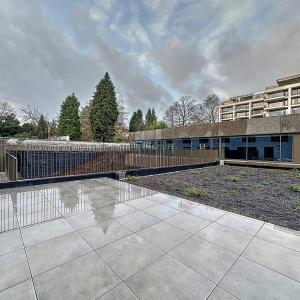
[129,114,300,142]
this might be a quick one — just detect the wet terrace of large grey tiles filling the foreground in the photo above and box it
[0,178,300,300]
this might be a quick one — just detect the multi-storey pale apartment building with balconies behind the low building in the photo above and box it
[219,74,300,122]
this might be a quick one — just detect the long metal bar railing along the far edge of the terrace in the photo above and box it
[1,142,218,181]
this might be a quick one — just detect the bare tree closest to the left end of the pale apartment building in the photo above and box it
[200,94,221,123]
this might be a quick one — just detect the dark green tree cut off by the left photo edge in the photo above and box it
[0,102,20,137]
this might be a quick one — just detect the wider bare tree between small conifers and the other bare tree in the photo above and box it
[164,96,200,127]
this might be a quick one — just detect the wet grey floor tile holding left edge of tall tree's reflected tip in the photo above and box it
[66,209,112,230]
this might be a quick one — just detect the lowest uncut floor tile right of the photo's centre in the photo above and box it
[170,237,238,284]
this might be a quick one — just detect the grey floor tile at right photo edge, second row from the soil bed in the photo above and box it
[243,238,300,281]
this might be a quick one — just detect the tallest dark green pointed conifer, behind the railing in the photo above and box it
[90,72,118,142]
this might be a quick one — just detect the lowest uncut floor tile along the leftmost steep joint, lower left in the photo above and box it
[26,232,93,276]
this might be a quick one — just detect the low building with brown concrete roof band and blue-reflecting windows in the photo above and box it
[129,114,300,167]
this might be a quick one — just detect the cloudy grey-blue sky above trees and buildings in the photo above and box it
[0,0,300,118]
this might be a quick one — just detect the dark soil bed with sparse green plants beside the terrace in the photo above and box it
[132,166,300,230]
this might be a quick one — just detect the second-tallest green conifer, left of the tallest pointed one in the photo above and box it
[58,93,80,140]
